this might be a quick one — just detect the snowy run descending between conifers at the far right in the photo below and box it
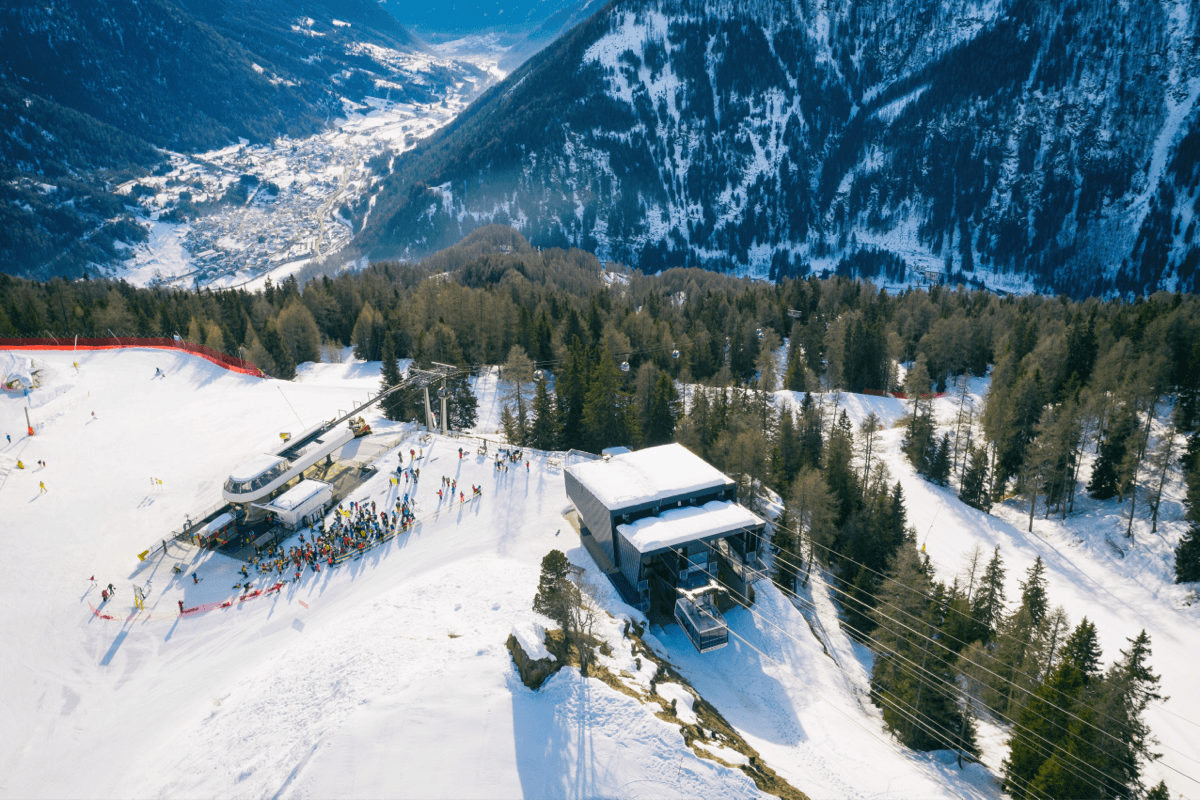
[758,378,1200,796]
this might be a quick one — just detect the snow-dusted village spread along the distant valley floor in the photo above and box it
[113,43,504,289]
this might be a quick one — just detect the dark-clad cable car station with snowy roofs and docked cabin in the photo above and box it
[564,444,766,652]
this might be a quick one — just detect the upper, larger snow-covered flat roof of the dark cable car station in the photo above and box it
[566,444,733,511]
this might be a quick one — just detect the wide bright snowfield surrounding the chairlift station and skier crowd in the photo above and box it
[0,350,757,798]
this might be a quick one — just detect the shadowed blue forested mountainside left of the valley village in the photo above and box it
[0,0,472,277]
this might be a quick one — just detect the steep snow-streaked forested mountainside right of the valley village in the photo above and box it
[359,0,1200,295]
